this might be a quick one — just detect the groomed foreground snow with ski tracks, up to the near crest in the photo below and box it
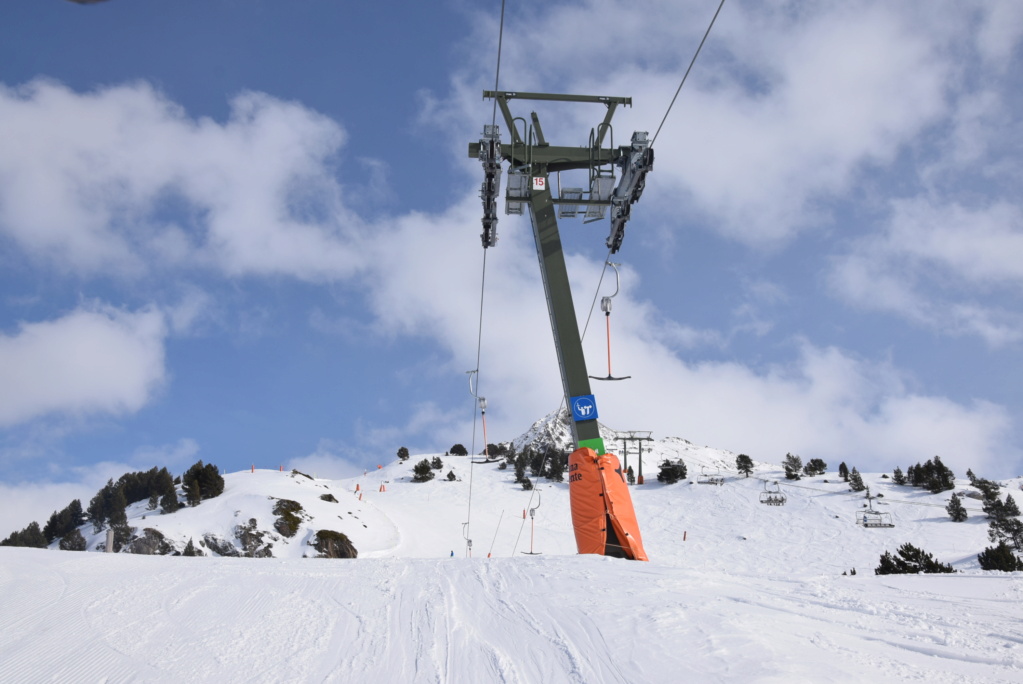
[0,548,1023,684]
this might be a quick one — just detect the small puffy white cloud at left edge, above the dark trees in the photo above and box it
[0,307,167,426]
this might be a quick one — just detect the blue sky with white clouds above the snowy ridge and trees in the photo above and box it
[0,0,1023,528]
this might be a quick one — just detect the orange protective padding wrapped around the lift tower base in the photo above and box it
[569,447,648,560]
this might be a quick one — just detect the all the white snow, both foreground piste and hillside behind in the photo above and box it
[0,413,1023,683]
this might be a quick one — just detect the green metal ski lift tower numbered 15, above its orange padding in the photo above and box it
[469,90,654,454]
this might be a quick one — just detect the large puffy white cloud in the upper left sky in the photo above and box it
[0,81,358,281]
